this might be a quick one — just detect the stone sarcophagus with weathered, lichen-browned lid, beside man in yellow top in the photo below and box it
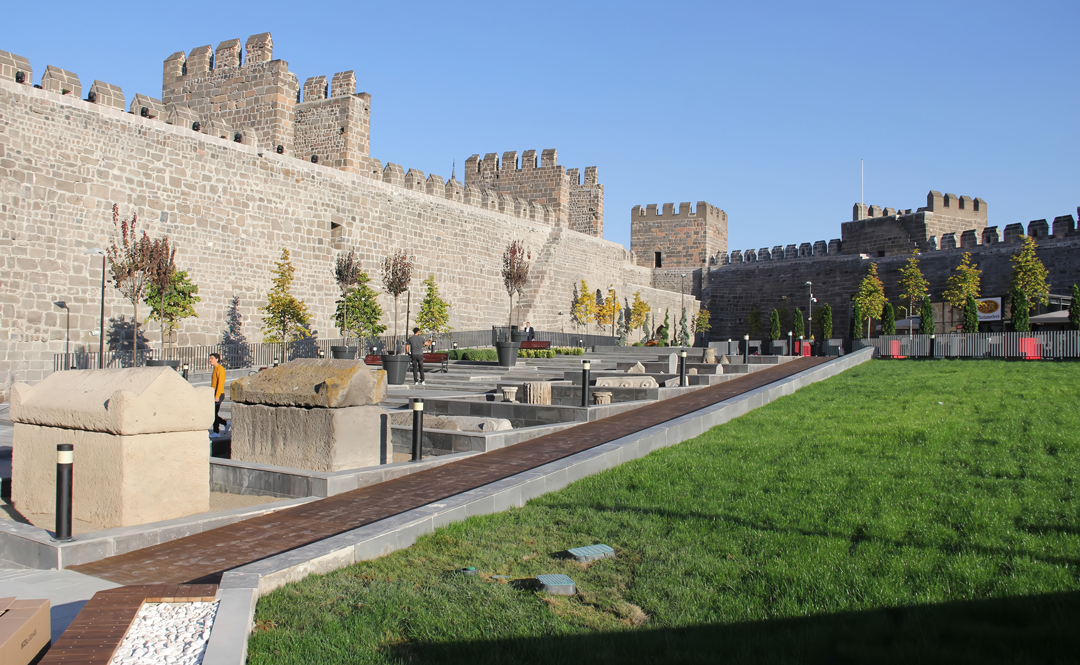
[230,358,391,472]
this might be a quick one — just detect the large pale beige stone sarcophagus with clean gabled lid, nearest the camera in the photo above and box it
[11,367,214,528]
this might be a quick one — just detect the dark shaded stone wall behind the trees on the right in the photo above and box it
[704,231,1080,339]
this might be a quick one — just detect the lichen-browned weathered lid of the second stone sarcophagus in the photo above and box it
[229,358,387,409]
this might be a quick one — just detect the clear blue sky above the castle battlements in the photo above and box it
[0,0,1080,249]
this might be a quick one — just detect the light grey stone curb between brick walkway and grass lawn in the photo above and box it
[203,349,873,665]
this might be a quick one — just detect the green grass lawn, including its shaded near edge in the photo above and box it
[249,361,1080,664]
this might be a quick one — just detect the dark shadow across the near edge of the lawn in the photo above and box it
[399,592,1080,665]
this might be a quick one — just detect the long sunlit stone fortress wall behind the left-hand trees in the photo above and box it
[0,80,679,393]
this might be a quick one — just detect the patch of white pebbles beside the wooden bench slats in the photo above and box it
[111,600,217,665]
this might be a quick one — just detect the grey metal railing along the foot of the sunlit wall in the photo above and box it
[53,326,615,372]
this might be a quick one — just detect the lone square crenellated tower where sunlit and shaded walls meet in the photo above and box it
[630,201,728,270]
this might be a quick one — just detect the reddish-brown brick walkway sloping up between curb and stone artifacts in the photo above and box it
[71,357,827,584]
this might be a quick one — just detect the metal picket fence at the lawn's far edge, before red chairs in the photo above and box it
[853,330,1080,359]
